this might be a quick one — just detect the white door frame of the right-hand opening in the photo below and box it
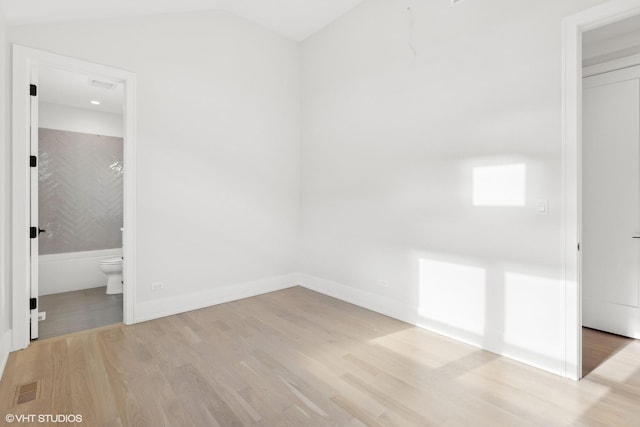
[562,0,640,380]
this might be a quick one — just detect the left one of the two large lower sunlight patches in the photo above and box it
[418,259,486,335]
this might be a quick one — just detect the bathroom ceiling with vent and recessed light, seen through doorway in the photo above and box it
[38,68,124,114]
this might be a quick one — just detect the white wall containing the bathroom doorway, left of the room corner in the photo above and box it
[9,12,300,318]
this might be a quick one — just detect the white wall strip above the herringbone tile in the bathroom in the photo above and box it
[38,102,124,138]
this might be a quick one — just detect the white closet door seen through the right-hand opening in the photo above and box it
[581,66,640,338]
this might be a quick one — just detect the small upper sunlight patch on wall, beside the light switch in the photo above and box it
[473,164,527,206]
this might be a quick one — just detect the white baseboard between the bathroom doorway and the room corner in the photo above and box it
[134,273,298,323]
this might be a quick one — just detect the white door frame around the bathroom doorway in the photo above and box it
[11,45,136,351]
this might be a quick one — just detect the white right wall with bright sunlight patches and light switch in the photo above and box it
[301,0,602,373]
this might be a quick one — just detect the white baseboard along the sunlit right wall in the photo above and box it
[298,273,565,376]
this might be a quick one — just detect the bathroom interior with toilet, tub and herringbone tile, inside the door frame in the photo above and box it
[38,67,125,339]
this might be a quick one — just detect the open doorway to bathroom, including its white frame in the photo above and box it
[12,45,135,350]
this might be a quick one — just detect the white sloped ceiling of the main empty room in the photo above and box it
[0,0,362,41]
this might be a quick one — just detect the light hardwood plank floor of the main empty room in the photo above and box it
[0,288,640,427]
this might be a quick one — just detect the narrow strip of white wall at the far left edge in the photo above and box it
[0,5,11,376]
